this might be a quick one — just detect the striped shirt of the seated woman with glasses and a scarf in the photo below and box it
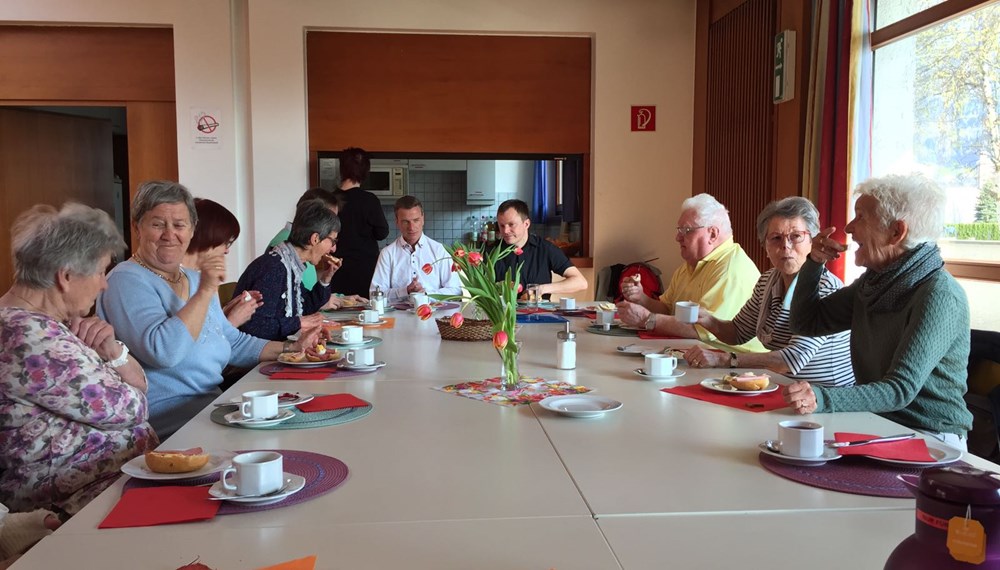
[733,268,854,386]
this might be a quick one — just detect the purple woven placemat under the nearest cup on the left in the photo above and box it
[122,449,350,515]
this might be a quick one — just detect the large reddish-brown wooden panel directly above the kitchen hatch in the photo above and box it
[306,32,591,153]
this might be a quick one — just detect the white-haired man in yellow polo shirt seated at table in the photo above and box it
[618,194,766,352]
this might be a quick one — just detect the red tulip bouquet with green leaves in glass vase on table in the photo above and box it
[417,242,522,390]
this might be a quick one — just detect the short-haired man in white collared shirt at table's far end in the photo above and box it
[370,196,462,303]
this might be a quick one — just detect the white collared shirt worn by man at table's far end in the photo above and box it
[369,234,462,303]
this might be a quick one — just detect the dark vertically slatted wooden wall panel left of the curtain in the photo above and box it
[704,0,776,269]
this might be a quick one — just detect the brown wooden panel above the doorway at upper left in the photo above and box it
[0,26,175,101]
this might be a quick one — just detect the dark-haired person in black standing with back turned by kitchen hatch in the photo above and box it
[332,147,389,297]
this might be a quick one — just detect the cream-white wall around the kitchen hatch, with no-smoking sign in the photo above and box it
[0,0,696,290]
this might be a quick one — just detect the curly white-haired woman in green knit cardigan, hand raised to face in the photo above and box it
[783,175,972,450]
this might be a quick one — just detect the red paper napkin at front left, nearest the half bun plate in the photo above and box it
[97,486,221,528]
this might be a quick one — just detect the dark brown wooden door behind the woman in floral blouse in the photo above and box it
[0,108,115,291]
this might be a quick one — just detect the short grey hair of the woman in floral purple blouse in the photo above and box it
[10,202,125,289]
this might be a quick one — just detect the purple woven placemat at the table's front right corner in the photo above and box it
[758,453,968,499]
